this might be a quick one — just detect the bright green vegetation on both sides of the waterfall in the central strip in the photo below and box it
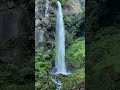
[35,0,85,90]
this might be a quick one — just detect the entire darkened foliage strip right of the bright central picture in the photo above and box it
[86,0,120,90]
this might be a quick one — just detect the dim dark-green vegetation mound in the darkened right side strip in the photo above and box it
[86,26,120,90]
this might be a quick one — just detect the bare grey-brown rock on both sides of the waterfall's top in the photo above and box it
[35,0,84,49]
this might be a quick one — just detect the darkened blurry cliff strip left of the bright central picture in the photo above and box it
[0,0,34,90]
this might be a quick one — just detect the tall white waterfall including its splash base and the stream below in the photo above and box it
[50,1,70,90]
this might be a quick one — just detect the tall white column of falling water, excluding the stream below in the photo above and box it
[55,1,67,74]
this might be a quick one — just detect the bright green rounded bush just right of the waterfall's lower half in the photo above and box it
[66,38,85,69]
